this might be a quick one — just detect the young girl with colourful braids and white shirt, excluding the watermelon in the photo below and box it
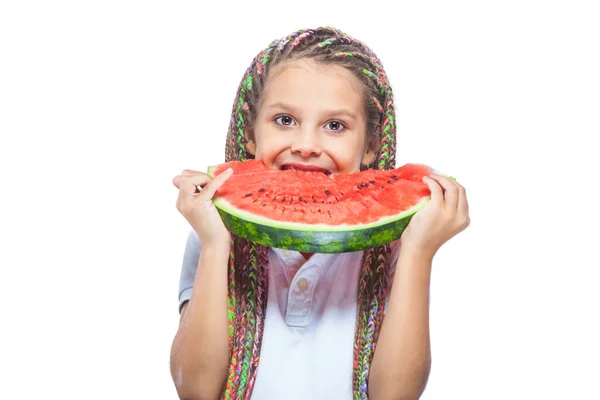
[171,27,469,400]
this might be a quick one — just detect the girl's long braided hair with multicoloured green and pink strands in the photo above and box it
[222,27,396,399]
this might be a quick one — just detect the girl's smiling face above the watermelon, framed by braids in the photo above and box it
[248,60,374,174]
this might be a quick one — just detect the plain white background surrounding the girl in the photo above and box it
[0,0,600,400]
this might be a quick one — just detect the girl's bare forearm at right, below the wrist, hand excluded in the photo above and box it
[369,247,433,400]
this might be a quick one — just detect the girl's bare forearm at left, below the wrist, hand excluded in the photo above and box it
[171,243,229,400]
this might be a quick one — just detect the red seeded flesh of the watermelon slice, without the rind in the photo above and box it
[210,160,433,226]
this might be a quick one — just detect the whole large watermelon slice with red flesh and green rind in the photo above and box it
[208,160,435,253]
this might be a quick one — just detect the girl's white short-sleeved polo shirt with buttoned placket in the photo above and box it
[179,231,400,400]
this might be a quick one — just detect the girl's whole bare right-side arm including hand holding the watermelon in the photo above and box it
[369,174,470,400]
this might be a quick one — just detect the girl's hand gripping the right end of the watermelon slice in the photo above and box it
[400,174,470,257]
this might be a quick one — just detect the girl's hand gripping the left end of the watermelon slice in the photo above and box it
[173,169,232,245]
